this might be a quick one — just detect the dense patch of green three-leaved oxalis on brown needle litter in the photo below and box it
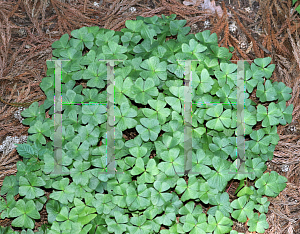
[0,14,293,234]
